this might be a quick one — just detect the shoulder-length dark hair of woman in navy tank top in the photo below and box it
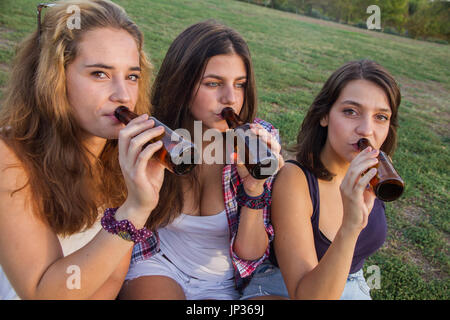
[292,60,401,180]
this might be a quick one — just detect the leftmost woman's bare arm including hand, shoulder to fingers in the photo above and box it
[0,117,164,299]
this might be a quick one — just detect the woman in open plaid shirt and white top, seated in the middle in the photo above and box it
[120,21,283,299]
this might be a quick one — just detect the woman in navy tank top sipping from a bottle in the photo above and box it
[251,60,401,299]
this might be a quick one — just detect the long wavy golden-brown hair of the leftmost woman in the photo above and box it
[0,0,151,235]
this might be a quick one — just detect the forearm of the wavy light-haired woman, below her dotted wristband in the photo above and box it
[33,230,133,299]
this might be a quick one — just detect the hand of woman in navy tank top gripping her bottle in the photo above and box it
[340,147,379,234]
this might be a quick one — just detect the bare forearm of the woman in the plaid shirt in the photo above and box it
[234,207,269,260]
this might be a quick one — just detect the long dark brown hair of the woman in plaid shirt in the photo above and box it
[146,20,257,230]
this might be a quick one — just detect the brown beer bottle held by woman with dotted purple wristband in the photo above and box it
[114,106,197,175]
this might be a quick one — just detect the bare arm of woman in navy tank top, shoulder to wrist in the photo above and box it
[272,164,374,299]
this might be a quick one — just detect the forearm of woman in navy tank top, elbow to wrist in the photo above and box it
[294,228,358,299]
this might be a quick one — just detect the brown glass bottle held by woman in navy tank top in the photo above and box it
[358,138,405,202]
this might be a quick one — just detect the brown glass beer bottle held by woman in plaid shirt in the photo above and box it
[221,107,278,179]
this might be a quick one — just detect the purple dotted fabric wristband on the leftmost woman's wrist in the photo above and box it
[101,208,152,243]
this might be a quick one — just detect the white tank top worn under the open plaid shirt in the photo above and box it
[158,210,234,281]
